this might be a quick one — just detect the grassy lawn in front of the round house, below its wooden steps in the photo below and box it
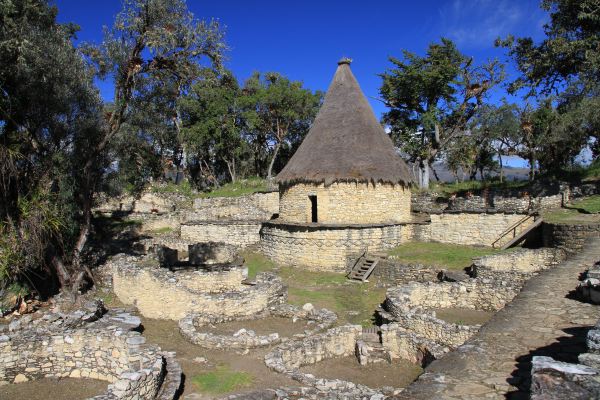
[243,251,385,326]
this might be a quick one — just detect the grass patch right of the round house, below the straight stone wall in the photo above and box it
[388,242,498,269]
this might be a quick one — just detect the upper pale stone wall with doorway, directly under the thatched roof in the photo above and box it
[279,183,411,224]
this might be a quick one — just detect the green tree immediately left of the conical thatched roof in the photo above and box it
[241,72,323,181]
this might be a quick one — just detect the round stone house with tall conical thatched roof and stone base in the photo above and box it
[261,60,412,271]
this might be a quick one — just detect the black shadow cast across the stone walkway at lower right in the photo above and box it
[505,326,593,400]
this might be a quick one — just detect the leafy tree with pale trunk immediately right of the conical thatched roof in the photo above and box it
[380,39,503,187]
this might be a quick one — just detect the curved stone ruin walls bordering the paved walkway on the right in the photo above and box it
[378,249,564,358]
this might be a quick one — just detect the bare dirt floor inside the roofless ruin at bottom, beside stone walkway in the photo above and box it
[300,356,423,388]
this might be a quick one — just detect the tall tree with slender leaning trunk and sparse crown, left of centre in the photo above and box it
[73,0,225,288]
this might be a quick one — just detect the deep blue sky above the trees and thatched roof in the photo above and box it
[56,0,547,166]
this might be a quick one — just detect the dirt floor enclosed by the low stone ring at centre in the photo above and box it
[205,317,315,337]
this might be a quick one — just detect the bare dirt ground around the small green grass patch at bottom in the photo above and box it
[142,318,298,399]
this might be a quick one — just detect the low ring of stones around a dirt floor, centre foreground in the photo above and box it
[179,304,337,350]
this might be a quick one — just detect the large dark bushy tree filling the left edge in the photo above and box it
[0,0,106,294]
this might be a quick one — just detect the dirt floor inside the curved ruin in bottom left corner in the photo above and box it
[0,378,108,400]
